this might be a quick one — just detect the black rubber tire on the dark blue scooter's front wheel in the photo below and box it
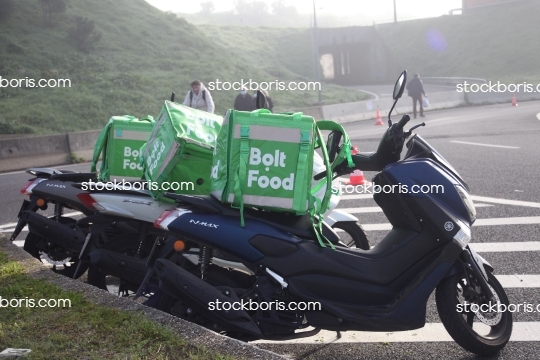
[435,272,512,356]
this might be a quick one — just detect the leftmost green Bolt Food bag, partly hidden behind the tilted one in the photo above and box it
[91,115,155,181]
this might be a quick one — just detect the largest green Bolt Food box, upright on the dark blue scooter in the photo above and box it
[211,109,331,215]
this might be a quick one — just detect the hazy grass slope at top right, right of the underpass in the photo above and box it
[379,1,540,84]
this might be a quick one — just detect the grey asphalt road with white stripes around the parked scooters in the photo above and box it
[0,99,540,359]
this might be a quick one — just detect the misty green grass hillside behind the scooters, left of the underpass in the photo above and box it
[0,0,364,133]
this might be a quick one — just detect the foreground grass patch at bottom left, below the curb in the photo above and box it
[0,252,234,359]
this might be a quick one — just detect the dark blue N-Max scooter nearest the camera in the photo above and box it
[148,71,512,355]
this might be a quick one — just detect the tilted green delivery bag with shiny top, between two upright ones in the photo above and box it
[143,101,223,201]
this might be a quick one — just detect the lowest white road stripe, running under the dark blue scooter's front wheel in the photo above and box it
[251,321,540,345]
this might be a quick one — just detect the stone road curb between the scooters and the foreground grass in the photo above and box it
[0,232,290,360]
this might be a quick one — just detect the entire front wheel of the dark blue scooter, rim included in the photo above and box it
[435,272,512,356]
